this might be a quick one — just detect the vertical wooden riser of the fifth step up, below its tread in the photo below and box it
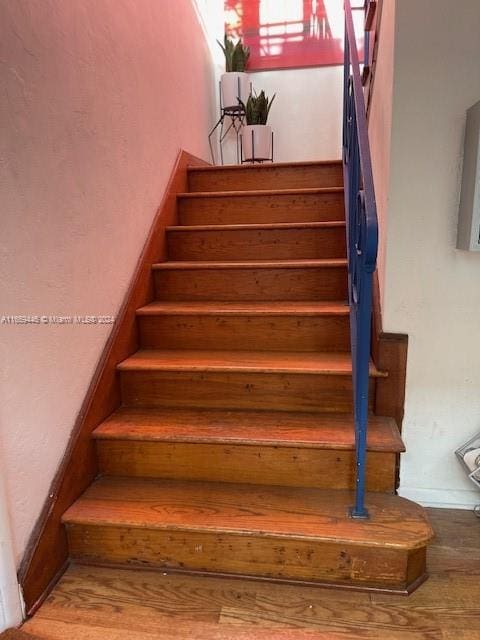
[154,267,347,301]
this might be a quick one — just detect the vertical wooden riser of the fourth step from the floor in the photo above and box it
[138,315,350,351]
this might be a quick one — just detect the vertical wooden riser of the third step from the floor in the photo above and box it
[120,371,374,413]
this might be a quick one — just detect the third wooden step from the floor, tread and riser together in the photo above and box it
[118,350,383,413]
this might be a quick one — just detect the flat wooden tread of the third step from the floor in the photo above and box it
[118,349,385,377]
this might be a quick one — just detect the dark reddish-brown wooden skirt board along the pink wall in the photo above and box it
[19,151,208,614]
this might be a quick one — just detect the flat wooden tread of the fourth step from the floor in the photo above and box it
[137,300,350,316]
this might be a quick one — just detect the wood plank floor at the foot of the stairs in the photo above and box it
[23,509,480,640]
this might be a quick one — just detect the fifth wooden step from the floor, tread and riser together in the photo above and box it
[152,259,347,302]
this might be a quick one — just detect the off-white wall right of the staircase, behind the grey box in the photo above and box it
[384,0,480,506]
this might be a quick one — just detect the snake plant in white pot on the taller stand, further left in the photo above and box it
[217,35,250,111]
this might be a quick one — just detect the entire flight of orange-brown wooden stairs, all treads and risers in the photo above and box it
[63,162,432,592]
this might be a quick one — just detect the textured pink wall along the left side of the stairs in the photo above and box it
[0,0,215,560]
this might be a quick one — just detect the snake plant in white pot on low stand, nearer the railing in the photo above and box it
[242,90,276,162]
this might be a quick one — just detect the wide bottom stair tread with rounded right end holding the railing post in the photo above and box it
[63,477,433,549]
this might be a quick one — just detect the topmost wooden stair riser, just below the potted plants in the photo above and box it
[188,162,343,191]
